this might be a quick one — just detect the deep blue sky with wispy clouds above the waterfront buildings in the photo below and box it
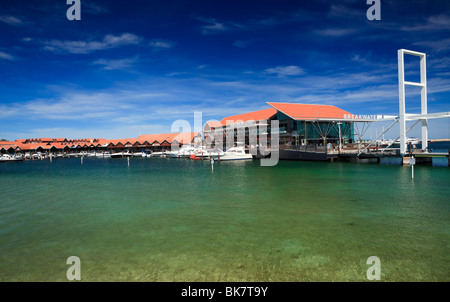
[0,0,450,140]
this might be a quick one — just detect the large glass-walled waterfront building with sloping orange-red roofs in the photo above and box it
[204,102,354,148]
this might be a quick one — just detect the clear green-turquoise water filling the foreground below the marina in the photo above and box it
[0,158,450,281]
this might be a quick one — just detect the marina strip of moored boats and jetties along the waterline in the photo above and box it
[0,136,450,166]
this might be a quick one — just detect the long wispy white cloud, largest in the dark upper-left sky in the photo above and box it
[43,33,142,54]
